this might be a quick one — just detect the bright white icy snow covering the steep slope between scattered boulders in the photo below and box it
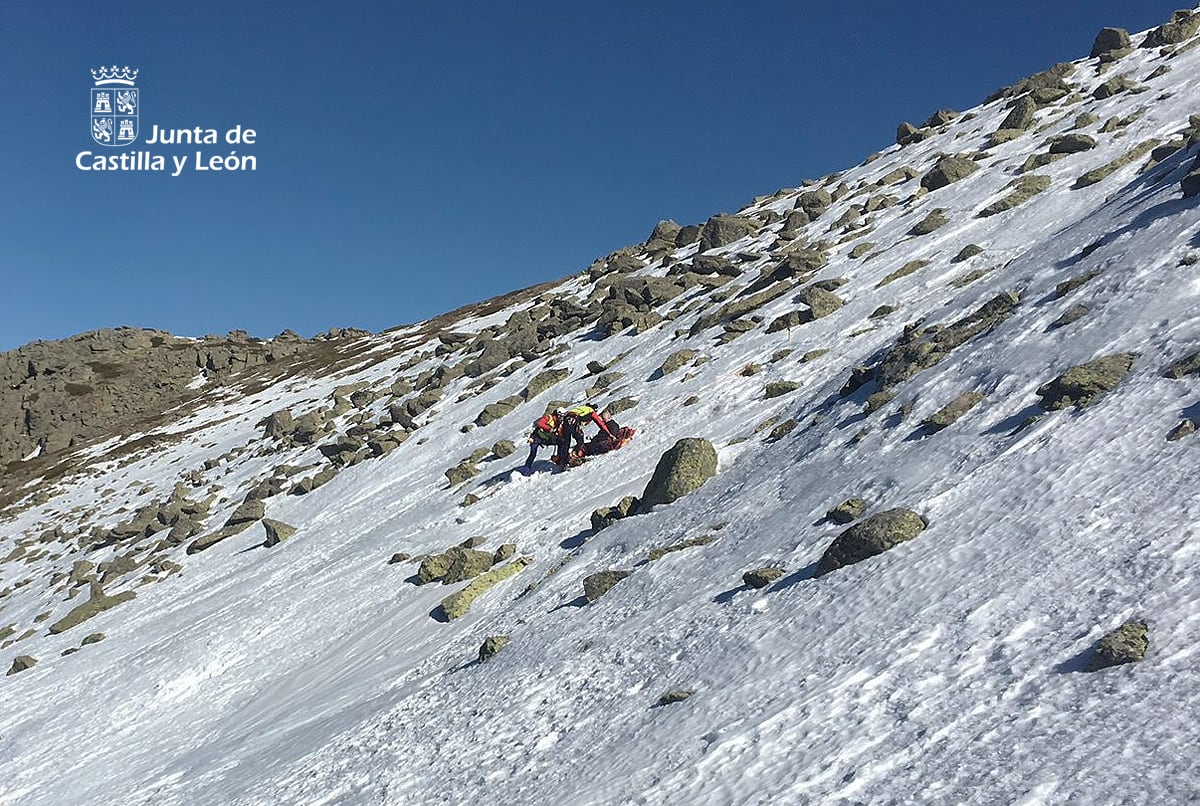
[0,12,1200,806]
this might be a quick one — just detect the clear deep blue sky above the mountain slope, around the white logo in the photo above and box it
[0,0,1187,350]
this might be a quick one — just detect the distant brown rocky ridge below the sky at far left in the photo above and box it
[0,327,324,464]
